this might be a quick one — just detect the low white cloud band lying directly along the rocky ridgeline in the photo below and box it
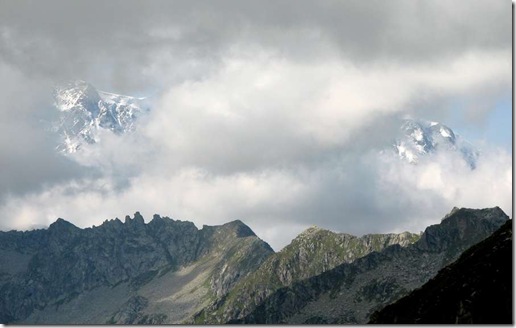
[2,132,512,250]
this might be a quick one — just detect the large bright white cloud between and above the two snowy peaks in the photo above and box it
[140,48,510,171]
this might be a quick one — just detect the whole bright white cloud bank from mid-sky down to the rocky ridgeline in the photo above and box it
[0,45,512,249]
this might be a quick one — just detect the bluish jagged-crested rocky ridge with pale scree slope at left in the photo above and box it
[0,213,273,324]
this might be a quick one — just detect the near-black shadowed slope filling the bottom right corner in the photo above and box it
[370,220,513,324]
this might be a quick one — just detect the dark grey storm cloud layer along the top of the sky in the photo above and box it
[0,0,511,92]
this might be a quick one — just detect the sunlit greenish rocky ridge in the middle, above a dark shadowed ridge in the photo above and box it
[189,227,420,324]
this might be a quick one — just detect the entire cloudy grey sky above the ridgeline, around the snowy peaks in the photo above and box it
[0,0,512,248]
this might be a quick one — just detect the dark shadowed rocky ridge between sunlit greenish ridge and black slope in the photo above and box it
[229,207,508,324]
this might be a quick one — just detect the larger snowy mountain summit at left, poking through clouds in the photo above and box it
[53,80,149,153]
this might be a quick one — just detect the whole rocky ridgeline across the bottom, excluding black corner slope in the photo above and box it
[0,208,508,324]
